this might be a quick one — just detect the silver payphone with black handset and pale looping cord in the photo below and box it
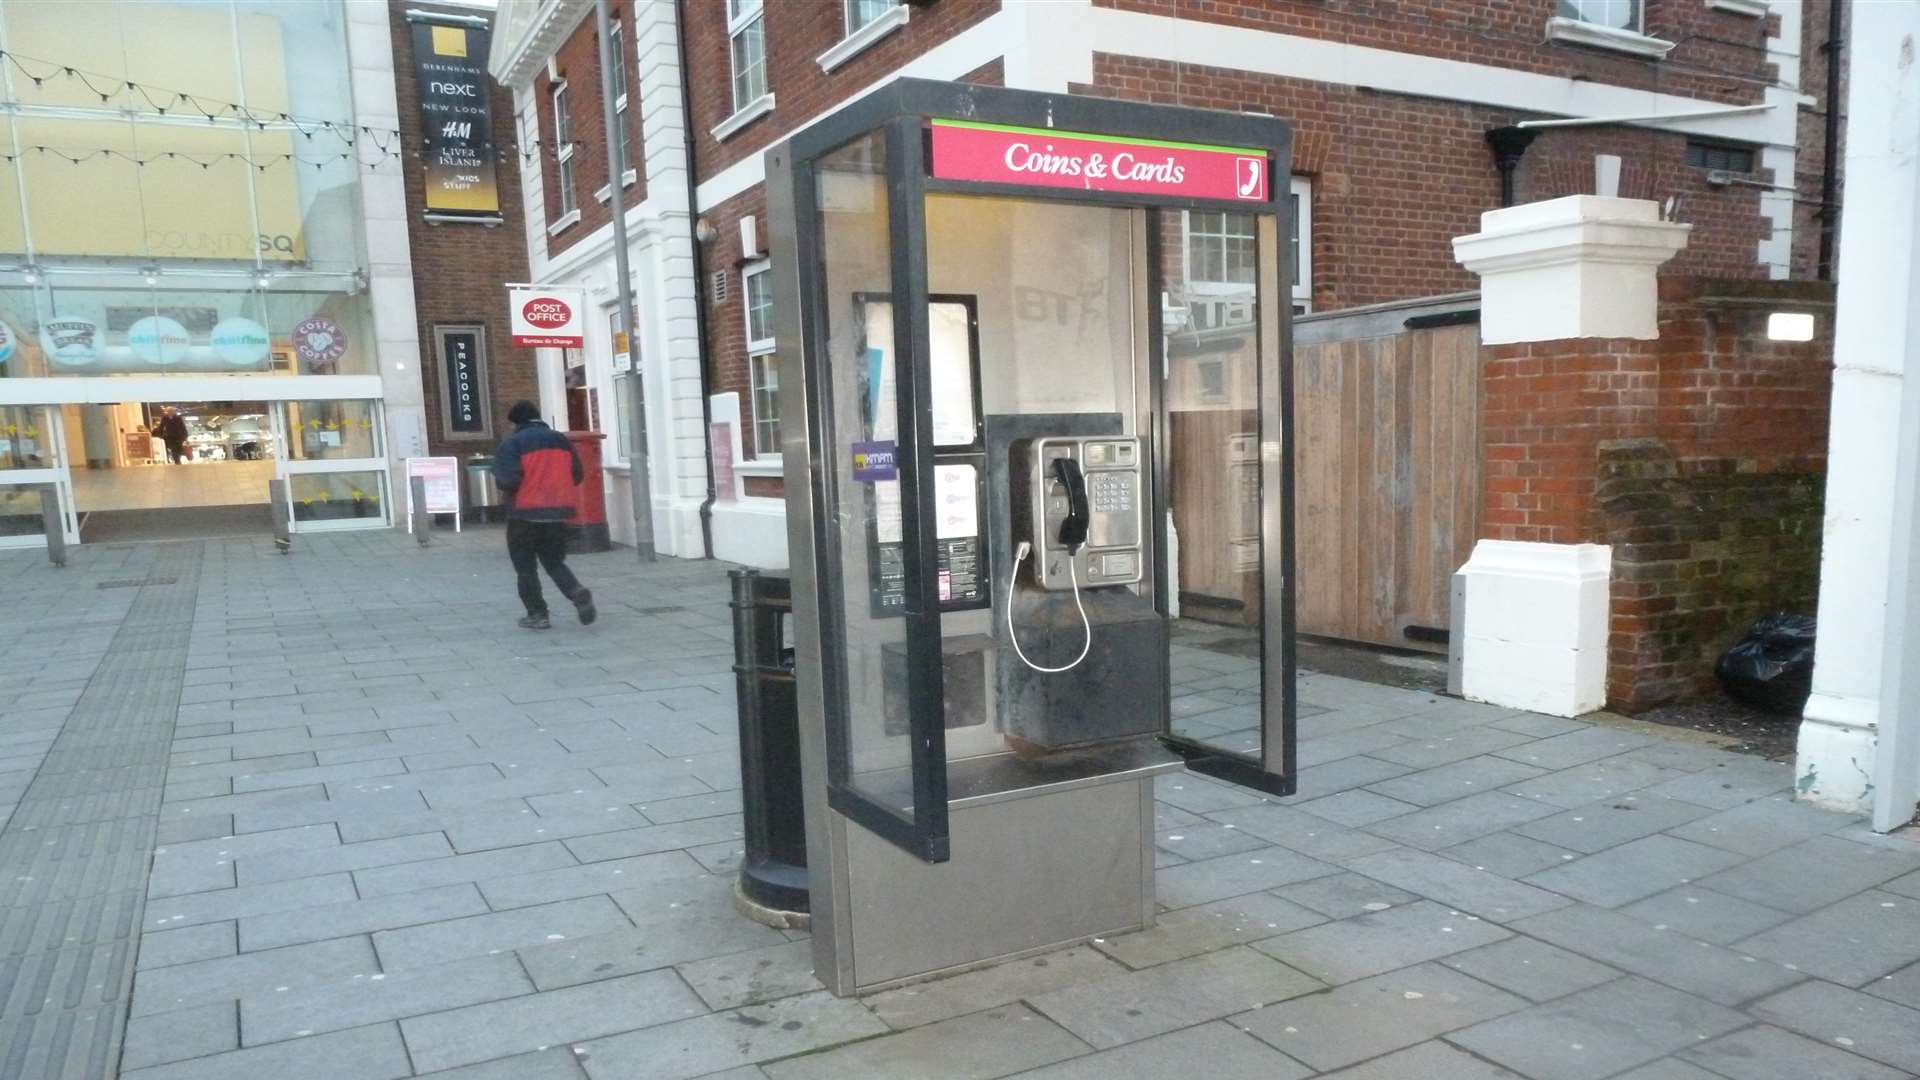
[1006,436,1144,675]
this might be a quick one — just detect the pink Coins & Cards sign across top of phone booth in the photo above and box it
[933,119,1269,202]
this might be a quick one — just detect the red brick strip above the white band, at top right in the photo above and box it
[1094,0,1776,104]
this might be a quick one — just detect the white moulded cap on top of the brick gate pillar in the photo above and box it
[1453,194,1692,344]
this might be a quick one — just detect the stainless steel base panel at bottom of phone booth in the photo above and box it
[814,774,1154,995]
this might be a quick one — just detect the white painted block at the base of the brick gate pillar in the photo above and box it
[1459,540,1613,717]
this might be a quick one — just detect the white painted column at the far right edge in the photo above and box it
[1795,4,1920,814]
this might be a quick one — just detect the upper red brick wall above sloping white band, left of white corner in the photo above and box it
[684,0,1000,181]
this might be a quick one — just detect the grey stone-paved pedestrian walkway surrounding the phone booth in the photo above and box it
[0,528,1920,1080]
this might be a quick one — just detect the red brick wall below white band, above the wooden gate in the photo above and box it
[1073,54,1770,311]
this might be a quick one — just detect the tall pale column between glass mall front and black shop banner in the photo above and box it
[342,4,426,486]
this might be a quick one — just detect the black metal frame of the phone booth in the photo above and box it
[791,79,1296,863]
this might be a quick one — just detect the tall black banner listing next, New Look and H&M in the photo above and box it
[407,12,499,221]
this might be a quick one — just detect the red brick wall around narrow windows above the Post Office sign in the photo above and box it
[534,4,648,258]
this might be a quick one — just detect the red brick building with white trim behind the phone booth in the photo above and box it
[492,0,1826,565]
